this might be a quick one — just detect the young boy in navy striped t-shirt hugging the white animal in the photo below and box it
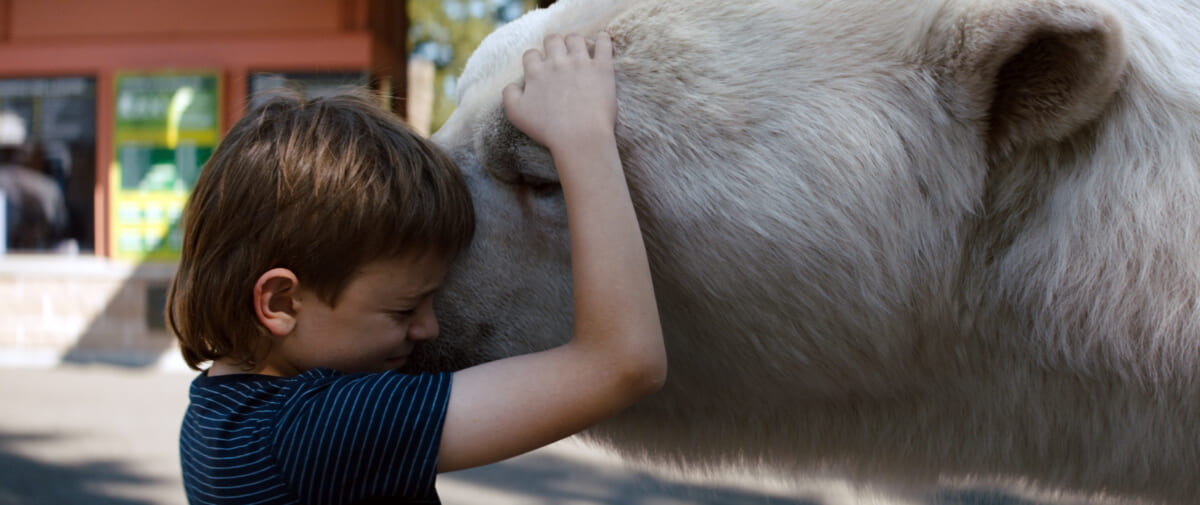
[168,34,666,504]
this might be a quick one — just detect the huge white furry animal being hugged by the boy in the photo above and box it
[414,0,1200,504]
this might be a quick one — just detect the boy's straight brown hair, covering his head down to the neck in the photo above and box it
[167,90,475,369]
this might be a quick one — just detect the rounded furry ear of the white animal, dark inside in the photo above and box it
[949,0,1126,150]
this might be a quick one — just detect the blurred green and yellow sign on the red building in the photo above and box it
[109,72,221,260]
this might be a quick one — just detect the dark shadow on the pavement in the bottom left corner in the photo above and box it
[0,433,157,505]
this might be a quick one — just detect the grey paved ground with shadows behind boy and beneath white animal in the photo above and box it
[0,365,1051,505]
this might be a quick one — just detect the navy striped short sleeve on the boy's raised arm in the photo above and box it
[271,372,451,505]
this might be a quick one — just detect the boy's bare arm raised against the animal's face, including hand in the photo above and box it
[438,34,667,471]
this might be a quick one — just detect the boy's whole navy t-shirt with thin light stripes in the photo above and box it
[179,368,451,505]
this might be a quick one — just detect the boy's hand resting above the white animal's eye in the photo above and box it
[504,32,617,152]
